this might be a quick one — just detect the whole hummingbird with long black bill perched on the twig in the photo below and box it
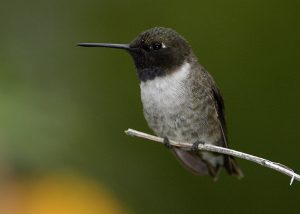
[78,27,243,179]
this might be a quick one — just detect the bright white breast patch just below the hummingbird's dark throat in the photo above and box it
[140,63,190,110]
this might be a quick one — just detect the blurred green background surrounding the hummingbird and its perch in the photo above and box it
[0,0,300,214]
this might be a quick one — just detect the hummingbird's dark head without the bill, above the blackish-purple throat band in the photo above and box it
[129,27,191,69]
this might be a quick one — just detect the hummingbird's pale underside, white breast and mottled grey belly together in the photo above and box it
[140,64,220,144]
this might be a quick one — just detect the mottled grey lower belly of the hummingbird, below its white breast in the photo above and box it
[142,91,216,144]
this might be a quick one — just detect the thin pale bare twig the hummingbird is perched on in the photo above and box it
[125,129,300,185]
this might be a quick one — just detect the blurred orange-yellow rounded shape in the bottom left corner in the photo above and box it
[0,174,127,214]
